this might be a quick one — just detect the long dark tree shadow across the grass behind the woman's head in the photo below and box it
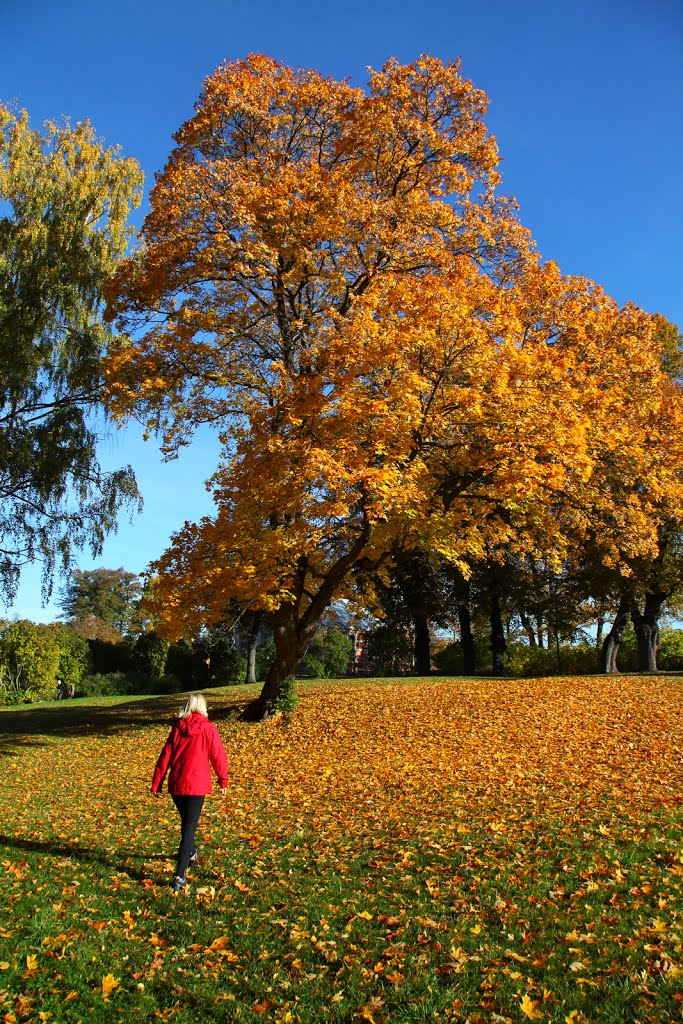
[0,687,253,757]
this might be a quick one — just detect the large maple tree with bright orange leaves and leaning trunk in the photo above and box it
[108,56,683,716]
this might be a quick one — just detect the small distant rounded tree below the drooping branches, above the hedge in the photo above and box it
[59,568,142,640]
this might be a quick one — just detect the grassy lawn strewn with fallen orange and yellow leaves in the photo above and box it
[0,677,683,1024]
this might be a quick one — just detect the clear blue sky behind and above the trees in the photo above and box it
[0,0,683,621]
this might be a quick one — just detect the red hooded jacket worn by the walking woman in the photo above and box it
[152,713,227,797]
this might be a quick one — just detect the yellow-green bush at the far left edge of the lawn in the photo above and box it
[0,620,88,703]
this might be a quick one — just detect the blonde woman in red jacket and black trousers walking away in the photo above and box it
[152,693,227,892]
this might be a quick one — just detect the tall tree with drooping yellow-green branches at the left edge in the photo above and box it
[0,103,142,600]
